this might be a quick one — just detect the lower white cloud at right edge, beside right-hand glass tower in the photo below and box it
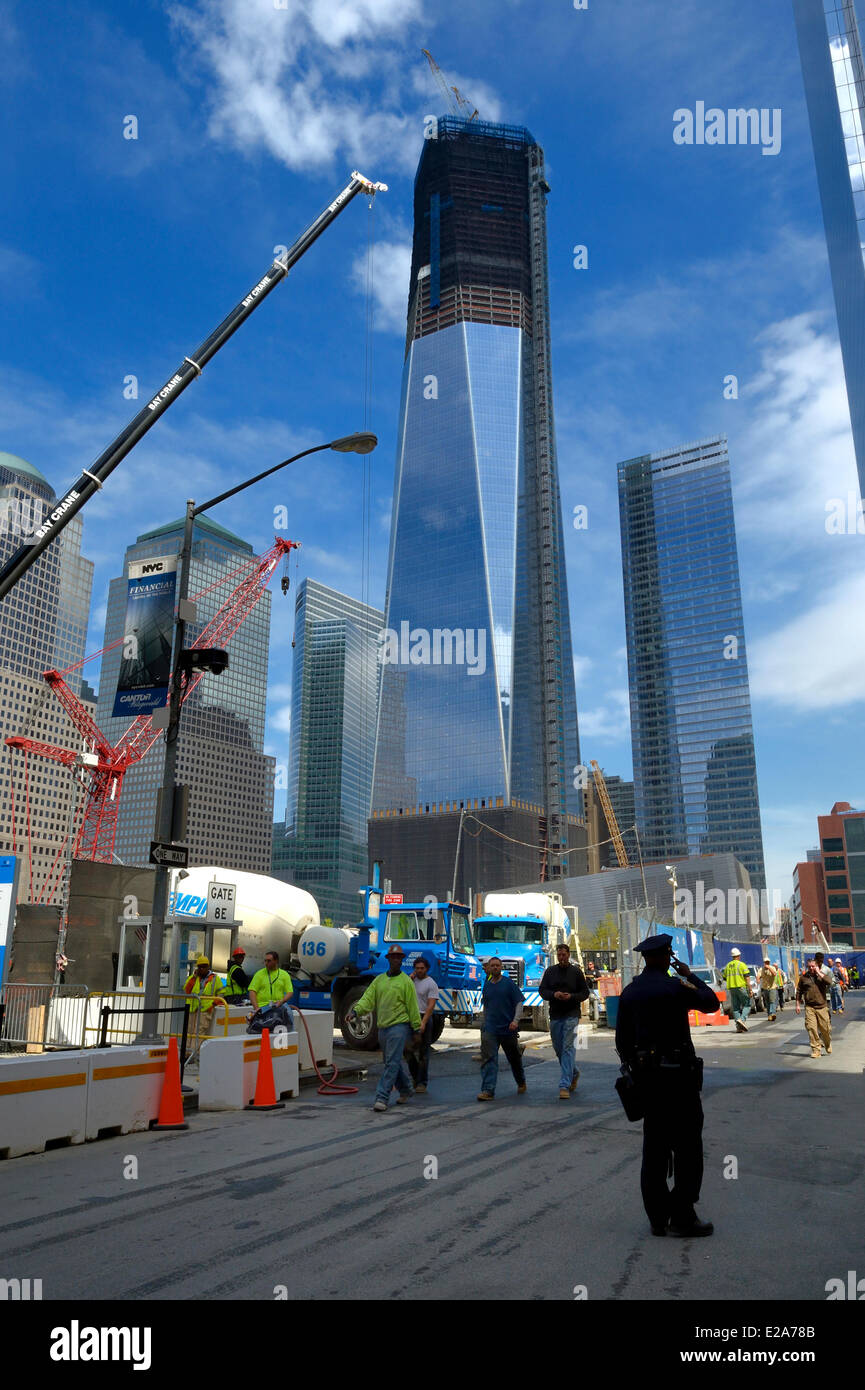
[748,569,865,712]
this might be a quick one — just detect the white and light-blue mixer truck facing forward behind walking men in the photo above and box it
[474,892,583,1031]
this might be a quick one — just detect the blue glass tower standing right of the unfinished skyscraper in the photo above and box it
[619,436,766,890]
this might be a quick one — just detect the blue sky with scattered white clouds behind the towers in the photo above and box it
[0,0,865,899]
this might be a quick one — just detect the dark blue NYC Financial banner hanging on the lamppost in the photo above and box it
[113,555,178,719]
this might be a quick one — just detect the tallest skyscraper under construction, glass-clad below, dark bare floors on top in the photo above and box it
[370,117,585,897]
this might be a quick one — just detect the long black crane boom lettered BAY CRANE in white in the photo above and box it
[0,171,387,599]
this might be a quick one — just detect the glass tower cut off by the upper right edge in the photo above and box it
[793,0,865,496]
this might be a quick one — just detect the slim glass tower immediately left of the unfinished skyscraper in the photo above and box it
[273,580,384,926]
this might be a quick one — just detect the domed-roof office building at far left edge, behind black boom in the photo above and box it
[0,453,93,902]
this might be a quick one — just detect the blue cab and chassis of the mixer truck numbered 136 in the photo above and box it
[298,866,485,1051]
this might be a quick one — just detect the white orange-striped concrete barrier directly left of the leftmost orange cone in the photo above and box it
[85,1047,168,1138]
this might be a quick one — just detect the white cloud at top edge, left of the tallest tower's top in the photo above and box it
[170,0,421,178]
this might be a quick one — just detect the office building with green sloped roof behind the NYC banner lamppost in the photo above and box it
[96,516,275,873]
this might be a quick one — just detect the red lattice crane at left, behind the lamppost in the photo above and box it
[6,537,299,902]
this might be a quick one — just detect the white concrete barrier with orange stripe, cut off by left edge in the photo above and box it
[0,1052,89,1158]
